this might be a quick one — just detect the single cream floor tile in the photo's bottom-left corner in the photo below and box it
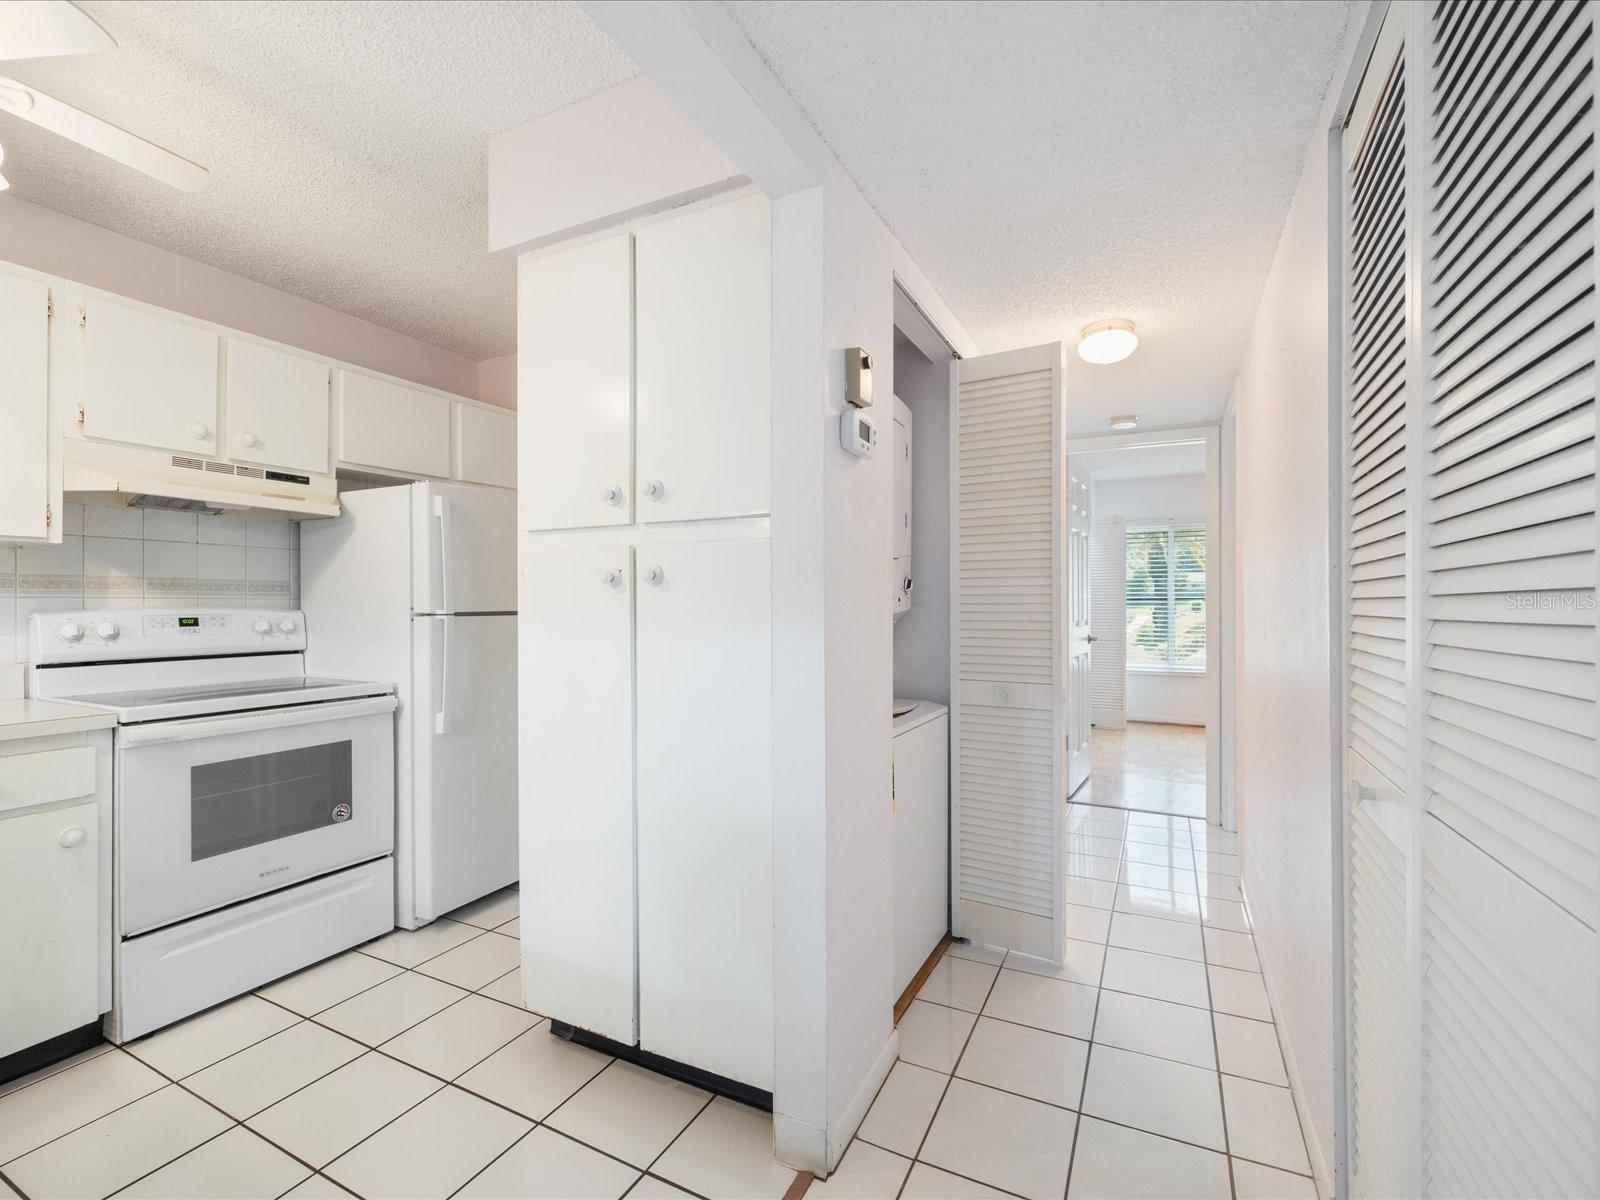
[5,1085,232,1200]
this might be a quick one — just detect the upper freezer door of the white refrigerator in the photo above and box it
[411,483,517,613]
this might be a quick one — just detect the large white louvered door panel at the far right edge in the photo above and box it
[1419,2,1600,1197]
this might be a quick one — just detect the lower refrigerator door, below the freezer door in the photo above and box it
[410,616,517,923]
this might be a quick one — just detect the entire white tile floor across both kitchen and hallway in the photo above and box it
[0,805,1315,1200]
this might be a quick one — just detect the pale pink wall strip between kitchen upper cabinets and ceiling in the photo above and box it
[0,195,499,408]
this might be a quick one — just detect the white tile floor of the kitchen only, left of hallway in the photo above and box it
[0,890,795,1200]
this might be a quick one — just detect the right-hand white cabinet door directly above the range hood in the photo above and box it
[226,338,328,475]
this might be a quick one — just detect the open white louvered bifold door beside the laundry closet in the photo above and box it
[950,344,1066,962]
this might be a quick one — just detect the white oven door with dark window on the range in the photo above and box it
[115,696,395,936]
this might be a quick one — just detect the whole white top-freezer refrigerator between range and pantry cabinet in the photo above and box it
[301,483,517,930]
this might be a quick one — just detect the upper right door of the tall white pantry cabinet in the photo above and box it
[635,195,773,522]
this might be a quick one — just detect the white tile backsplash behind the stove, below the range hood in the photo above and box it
[0,502,299,662]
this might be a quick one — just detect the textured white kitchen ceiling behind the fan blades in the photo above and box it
[0,0,638,358]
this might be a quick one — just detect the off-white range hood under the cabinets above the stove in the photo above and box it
[61,437,339,520]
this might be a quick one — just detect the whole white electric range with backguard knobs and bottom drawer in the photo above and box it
[29,608,395,1042]
